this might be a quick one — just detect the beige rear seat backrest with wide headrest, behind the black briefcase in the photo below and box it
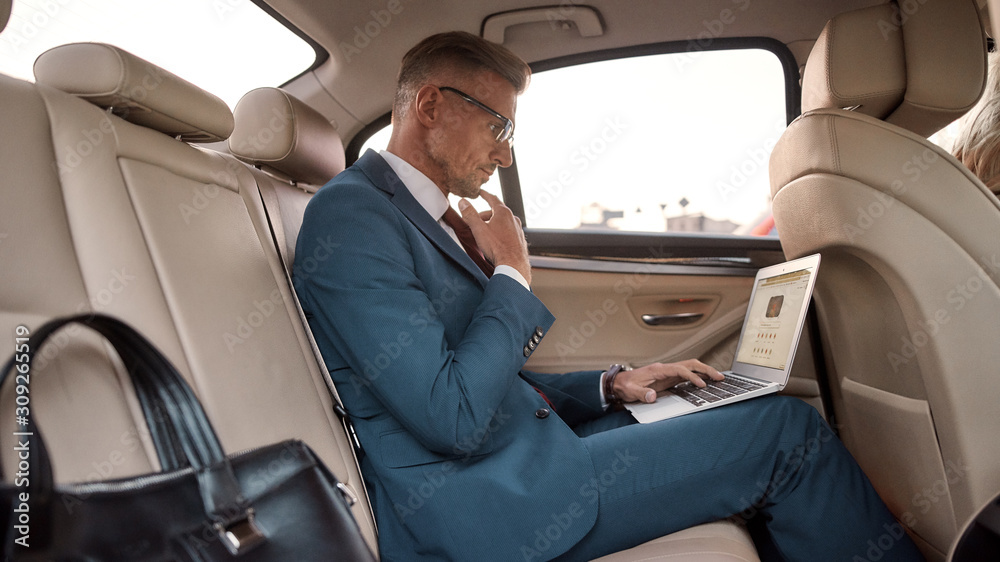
[0,44,375,549]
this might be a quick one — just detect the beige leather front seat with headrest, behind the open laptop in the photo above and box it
[770,0,1000,560]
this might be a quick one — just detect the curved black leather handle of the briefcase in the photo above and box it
[0,313,263,554]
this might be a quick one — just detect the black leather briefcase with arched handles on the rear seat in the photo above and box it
[0,315,374,562]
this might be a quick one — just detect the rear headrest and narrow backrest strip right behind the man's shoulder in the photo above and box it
[229,88,345,264]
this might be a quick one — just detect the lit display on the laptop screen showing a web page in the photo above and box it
[736,269,812,370]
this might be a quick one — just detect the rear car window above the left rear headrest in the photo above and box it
[0,0,316,108]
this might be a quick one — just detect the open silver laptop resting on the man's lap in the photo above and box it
[626,254,819,423]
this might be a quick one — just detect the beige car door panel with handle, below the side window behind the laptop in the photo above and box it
[526,232,824,412]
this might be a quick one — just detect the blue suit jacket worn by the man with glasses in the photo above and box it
[294,151,603,560]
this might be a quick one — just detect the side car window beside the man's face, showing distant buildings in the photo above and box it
[515,49,787,234]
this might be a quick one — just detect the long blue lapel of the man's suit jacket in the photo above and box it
[354,150,489,287]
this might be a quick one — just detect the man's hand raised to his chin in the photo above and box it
[458,191,531,285]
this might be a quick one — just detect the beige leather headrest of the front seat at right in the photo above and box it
[802,0,986,137]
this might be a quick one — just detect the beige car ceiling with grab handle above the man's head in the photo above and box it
[258,0,936,144]
